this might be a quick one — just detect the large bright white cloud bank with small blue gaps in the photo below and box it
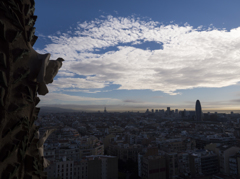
[35,16,240,95]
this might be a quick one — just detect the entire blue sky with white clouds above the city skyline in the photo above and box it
[34,0,240,111]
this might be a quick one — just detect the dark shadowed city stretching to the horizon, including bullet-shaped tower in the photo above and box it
[38,100,240,179]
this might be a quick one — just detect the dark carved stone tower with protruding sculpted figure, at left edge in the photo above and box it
[0,0,64,179]
